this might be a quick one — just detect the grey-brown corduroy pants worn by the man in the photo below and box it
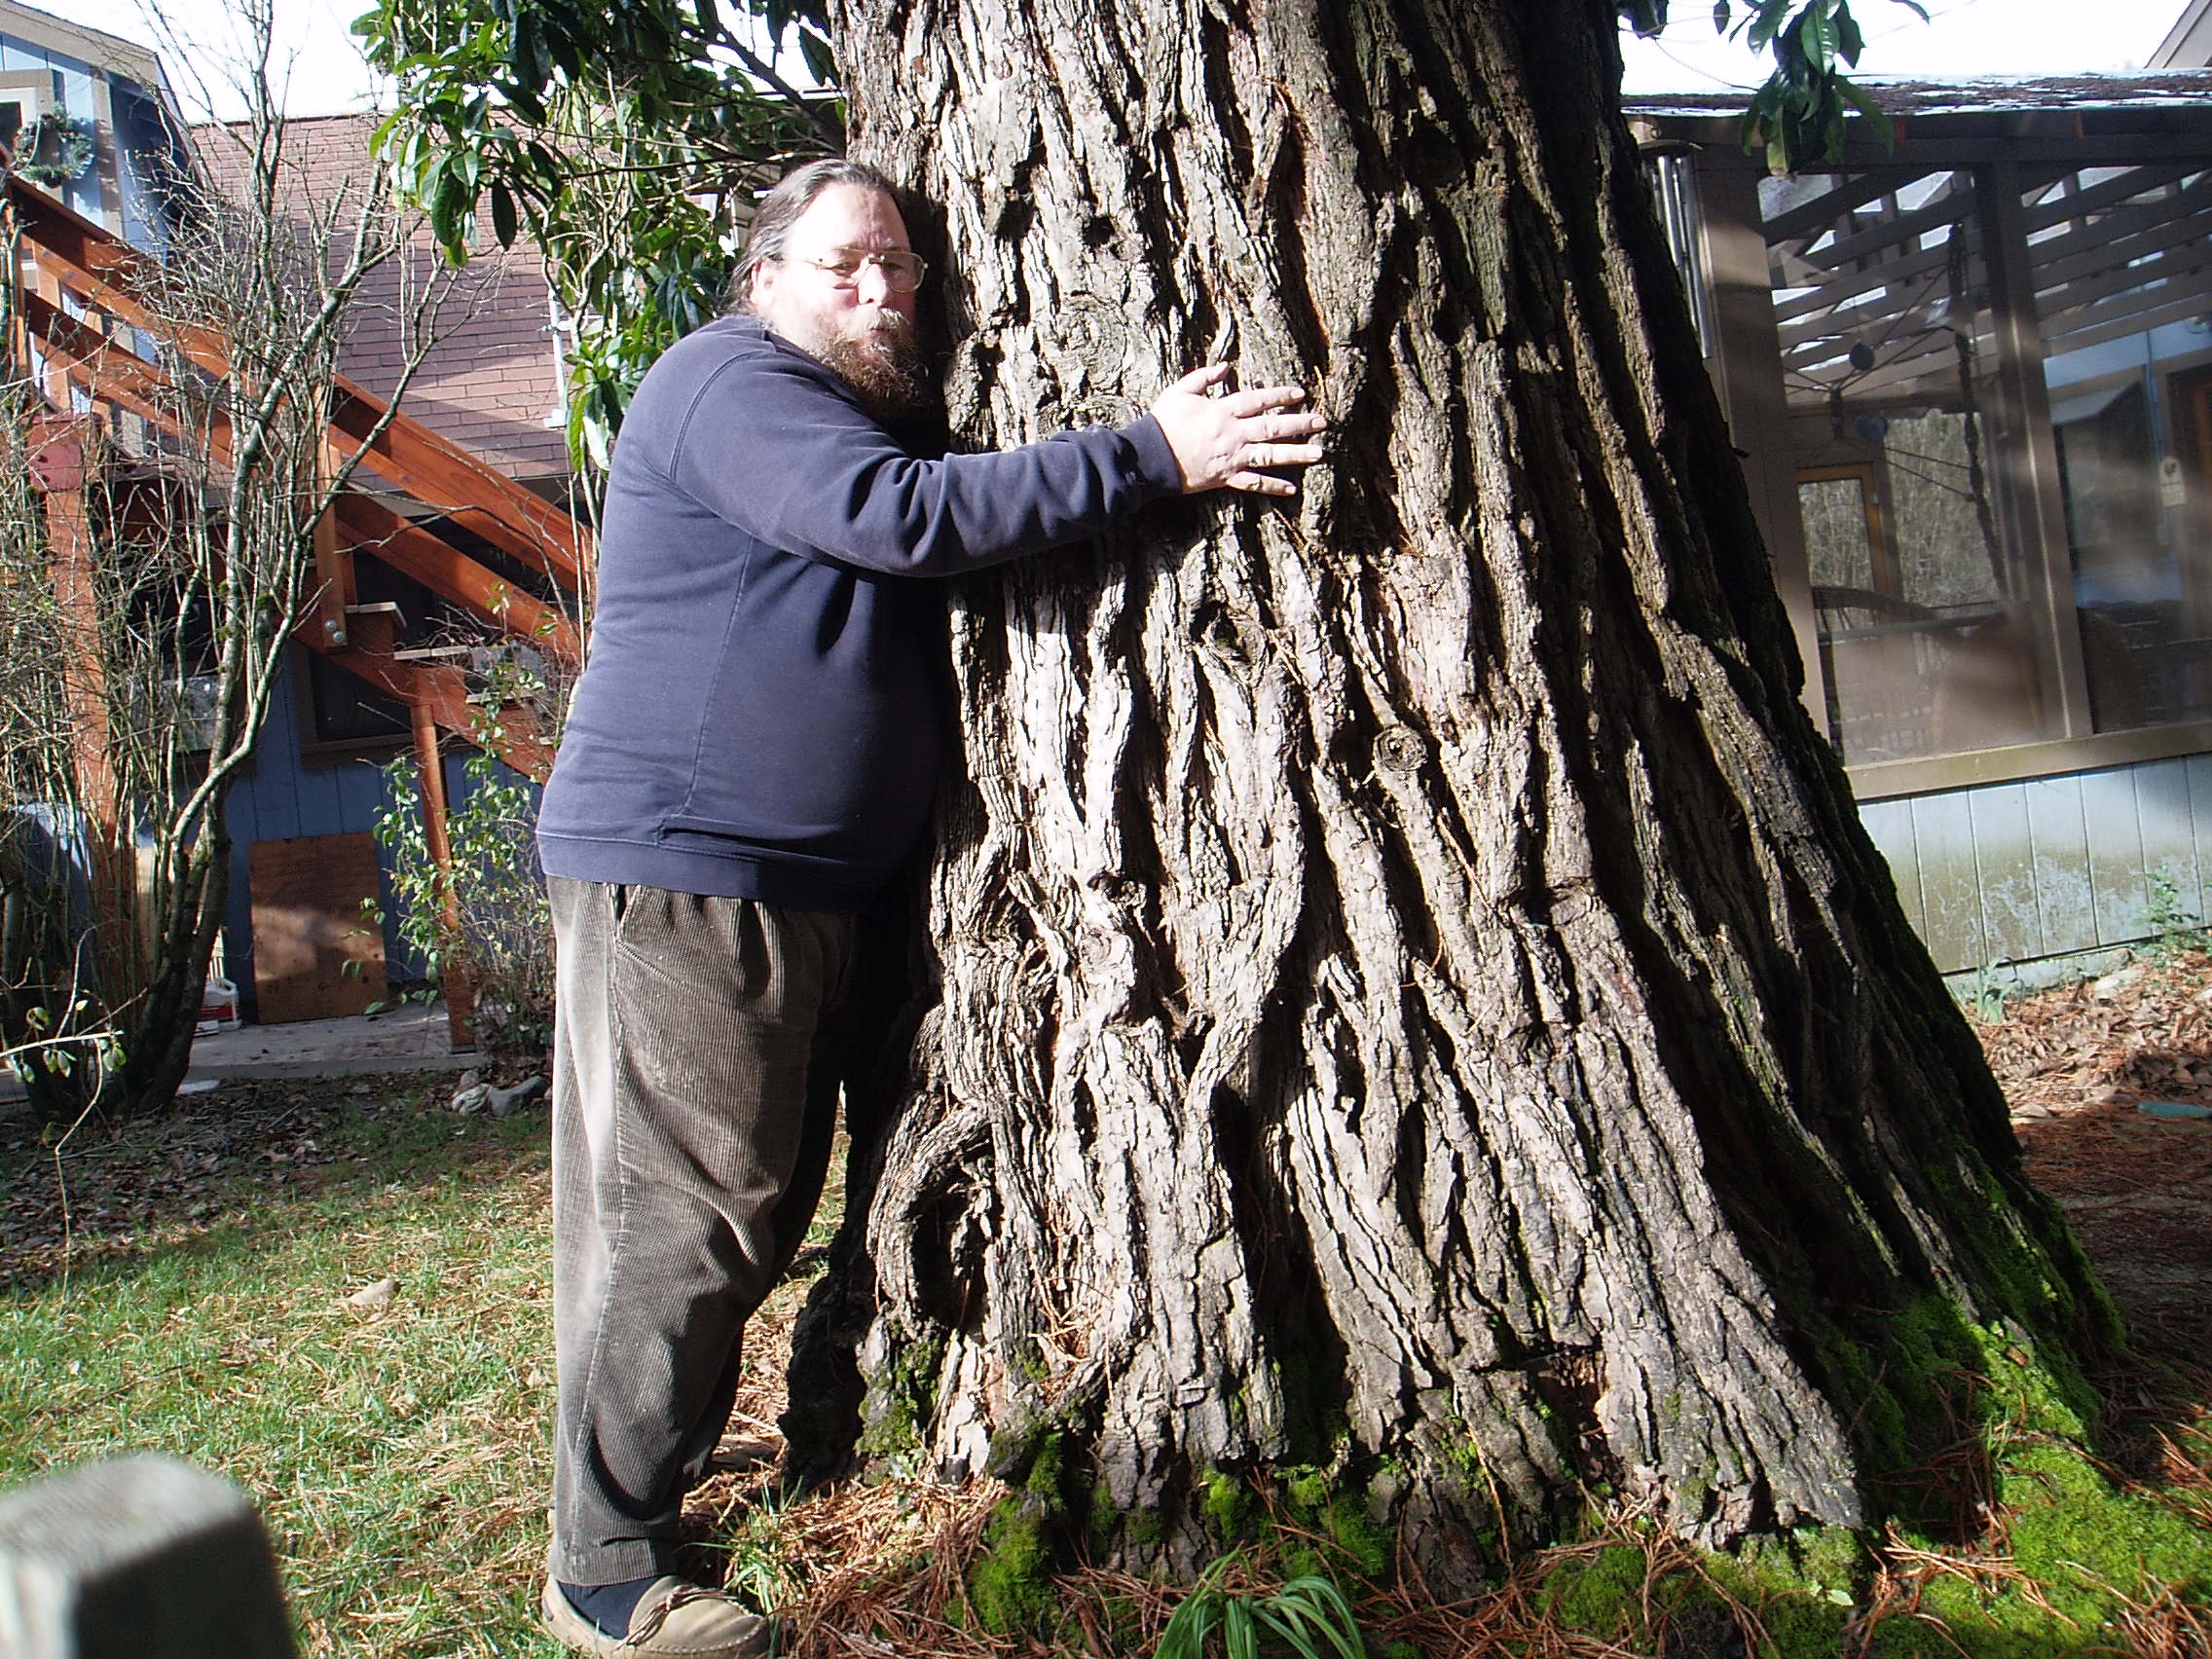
[548,876,856,1584]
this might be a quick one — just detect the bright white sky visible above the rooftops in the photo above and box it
[69,0,2212,115]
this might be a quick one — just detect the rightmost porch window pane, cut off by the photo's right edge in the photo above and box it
[2022,162,2212,732]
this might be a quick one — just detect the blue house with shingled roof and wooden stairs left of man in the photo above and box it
[0,0,584,1039]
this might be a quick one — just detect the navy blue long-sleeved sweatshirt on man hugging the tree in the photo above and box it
[537,316,1181,909]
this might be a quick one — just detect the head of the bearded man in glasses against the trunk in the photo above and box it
[752,184,922,416]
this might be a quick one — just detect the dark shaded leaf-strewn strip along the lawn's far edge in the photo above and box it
[0,1073,551,1296]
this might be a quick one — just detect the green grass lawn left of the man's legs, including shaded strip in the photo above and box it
[0,1080,555,1657]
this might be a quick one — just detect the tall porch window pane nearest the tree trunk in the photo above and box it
[1761,168,2052,765]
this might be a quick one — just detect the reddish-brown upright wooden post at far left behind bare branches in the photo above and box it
[31,414,137,998]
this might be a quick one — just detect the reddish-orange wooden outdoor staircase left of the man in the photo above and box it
[5,177,591,781]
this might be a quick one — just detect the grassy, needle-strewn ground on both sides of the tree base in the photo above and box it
[0,991,2212,1659]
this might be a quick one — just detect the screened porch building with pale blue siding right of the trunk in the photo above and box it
[1630,78,2212,977]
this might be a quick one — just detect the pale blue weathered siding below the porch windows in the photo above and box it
[1858,755,2212,974]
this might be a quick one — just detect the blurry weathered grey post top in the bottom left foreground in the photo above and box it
[0,1456,294,1659]
